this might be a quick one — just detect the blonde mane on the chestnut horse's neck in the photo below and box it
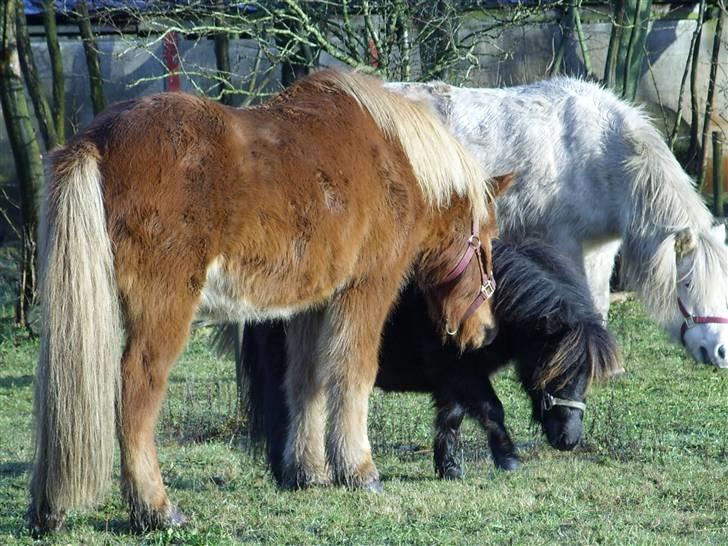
[315,70,493,223]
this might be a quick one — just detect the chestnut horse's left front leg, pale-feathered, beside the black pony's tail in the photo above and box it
[282,312,331,488]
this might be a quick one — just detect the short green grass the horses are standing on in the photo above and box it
[0,302,728,545]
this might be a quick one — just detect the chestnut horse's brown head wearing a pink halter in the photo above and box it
[421,175,513,350]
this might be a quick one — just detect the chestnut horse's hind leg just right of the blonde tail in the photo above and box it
[118,291,199,530]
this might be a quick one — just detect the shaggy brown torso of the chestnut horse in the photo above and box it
[69,88,427,318]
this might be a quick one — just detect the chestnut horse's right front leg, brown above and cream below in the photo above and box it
[321,280,397,491]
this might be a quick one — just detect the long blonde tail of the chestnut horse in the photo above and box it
[29,141,122,529]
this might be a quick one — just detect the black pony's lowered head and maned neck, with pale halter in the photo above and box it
[493,239,623,450]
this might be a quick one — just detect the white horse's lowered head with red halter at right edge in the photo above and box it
[671,225,728,368]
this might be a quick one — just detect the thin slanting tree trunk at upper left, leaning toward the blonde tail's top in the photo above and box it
[16,2,58,150]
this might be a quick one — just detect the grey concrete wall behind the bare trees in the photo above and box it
[0,9,728,239]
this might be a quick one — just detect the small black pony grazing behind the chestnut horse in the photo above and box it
[221,240,620,482]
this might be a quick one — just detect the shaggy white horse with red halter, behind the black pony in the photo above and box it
[389,78,728,368]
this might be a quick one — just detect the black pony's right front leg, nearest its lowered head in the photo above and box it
[467,379,521,470]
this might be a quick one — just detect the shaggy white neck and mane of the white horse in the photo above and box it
[622,114,712,323]
